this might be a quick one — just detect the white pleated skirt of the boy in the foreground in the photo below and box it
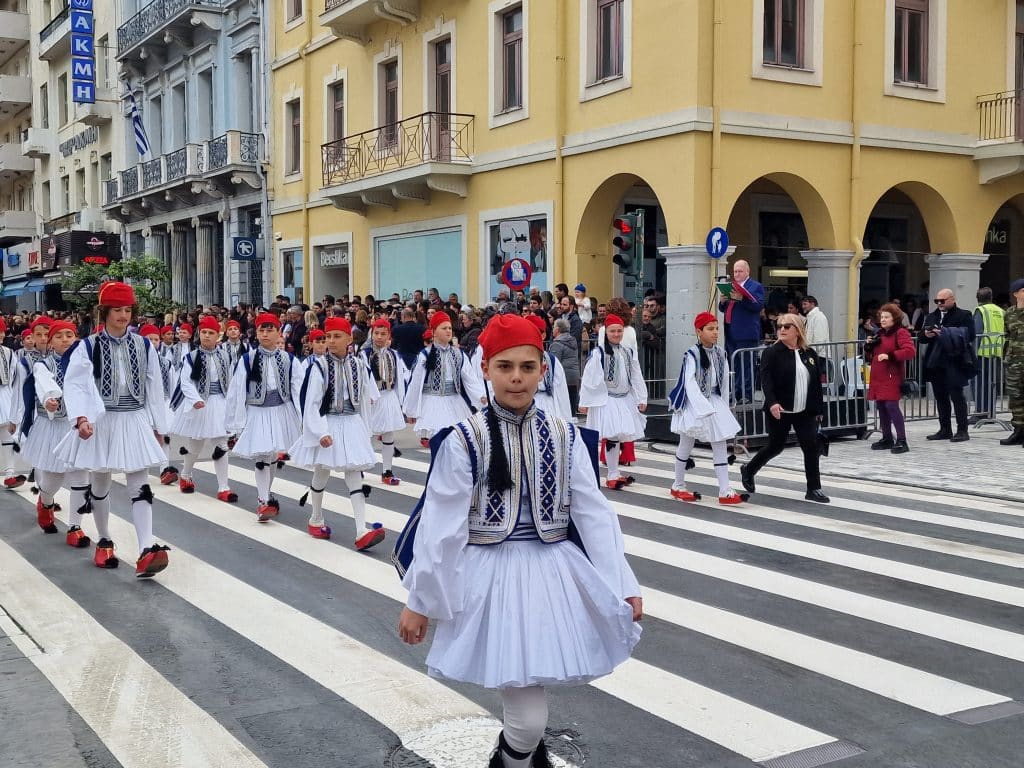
[427,541,640,688]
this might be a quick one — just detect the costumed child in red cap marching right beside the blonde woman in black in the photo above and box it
[669,312,749,504]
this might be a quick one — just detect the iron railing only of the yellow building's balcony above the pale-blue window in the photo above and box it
[321,112,473,186]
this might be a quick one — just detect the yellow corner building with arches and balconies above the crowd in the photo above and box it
[270,0,1024,357]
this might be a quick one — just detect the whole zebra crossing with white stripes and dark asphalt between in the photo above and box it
[0,450,1024,768]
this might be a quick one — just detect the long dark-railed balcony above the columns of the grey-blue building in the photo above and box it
[103,131,264,208]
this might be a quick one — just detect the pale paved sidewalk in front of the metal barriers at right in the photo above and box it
[740,420,1024,501]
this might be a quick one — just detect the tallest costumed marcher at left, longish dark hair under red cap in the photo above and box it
[55,282,169,578]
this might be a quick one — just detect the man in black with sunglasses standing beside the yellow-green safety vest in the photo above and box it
[919,288,976,442]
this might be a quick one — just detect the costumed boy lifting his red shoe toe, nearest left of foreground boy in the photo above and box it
[289,317,384,551]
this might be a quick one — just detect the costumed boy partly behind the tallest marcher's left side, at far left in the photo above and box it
[22,321,91,549]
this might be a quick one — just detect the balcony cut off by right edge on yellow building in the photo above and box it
[974,90,1024,184]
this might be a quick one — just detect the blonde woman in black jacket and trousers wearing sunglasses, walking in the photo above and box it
[739,314,828,504]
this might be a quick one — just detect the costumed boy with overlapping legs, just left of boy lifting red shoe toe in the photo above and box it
[224,312,303,522]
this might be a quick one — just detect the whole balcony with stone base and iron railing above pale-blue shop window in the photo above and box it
[321,112,474,212]
